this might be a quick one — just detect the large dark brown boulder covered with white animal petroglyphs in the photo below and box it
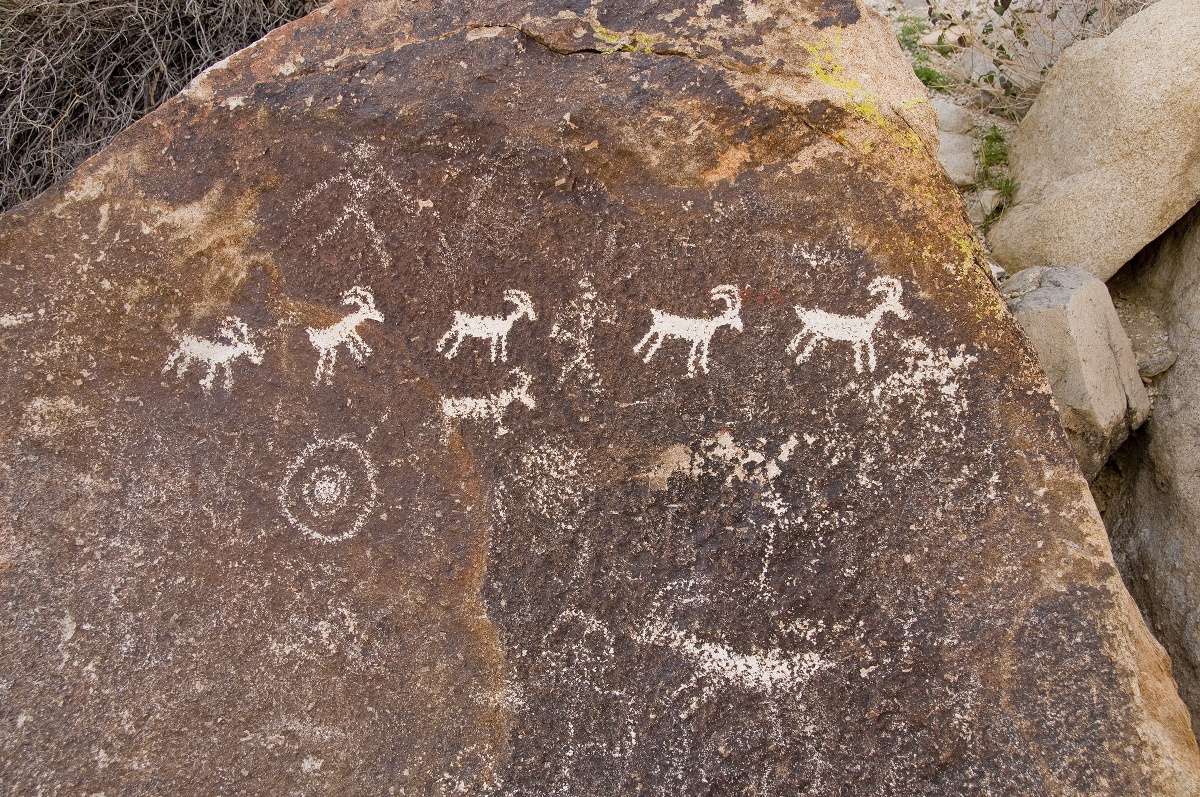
[0,0,1200,795]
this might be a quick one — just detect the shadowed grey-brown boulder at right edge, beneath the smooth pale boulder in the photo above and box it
[1104,202,1200,739]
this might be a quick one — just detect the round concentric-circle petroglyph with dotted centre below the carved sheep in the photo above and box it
[280,439,379,543]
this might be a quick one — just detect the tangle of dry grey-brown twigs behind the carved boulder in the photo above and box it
[0,0,319,211]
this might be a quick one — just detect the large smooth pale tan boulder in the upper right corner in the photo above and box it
[988,0,1200,280]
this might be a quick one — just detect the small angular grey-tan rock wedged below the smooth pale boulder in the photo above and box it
[1001,266,1150,481]
